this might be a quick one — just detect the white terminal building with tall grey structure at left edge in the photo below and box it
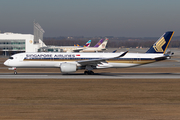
[0,24,46,56]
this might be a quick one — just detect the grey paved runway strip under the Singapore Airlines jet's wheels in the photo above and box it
[0,73,180,79]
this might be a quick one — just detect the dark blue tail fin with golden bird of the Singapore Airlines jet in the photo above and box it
[146,31,174,54]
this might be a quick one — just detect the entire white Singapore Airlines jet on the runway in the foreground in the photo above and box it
[4,31,174,74]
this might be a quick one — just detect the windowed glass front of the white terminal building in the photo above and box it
[0,39,25,51]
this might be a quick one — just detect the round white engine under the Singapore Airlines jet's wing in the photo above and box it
[60,63,77,73]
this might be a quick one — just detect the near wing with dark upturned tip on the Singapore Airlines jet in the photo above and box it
[77,51,128,66]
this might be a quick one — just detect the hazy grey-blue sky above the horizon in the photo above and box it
[0,0,180,37]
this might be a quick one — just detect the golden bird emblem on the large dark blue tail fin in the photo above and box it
[153,37,166,52]
